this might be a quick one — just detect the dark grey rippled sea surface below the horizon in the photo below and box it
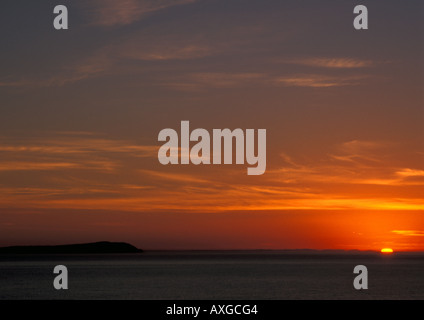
[0,251,424,300]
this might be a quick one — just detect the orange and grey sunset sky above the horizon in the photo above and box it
[0,0,424,251]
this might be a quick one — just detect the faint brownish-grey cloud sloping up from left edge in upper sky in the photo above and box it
[0,29,219,88]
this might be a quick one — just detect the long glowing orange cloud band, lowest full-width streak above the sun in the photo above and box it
[4,184,424,214]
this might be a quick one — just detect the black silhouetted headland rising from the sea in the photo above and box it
[0,241,143,254]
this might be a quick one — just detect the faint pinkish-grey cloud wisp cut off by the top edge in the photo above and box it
[85,0,196,27]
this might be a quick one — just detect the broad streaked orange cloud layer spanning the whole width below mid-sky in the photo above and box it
[0,136,424,214]
